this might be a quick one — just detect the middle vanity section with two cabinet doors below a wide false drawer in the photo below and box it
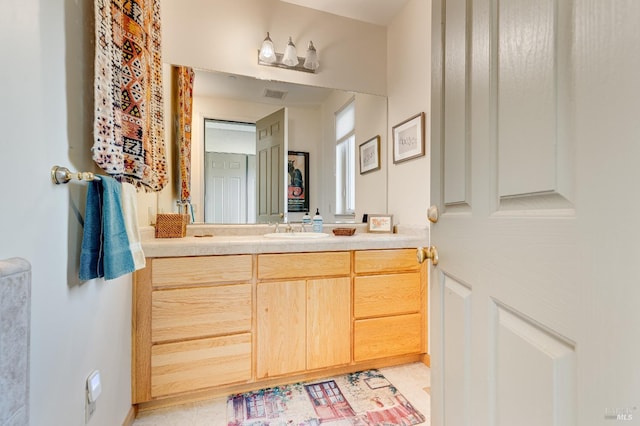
[256,252,351,379]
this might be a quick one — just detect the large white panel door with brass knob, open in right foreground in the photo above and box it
[430,0,640,426]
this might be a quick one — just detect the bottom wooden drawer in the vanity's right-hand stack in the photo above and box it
[353,314,423,361]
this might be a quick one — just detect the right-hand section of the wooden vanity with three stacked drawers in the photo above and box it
[353,249,427,362]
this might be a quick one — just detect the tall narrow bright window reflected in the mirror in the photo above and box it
[336,100,356,215]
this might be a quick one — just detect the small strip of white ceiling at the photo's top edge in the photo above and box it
[281,0,409,26]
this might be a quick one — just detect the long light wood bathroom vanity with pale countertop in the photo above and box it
[132,226,429,409]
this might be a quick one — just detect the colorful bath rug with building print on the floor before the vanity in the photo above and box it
[227,370,425,426]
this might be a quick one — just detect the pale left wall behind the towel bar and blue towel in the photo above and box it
[0,0,131,426]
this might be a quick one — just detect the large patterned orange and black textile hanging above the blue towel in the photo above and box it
[92,0,167,191]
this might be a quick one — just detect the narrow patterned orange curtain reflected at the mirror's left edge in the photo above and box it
[173,66,195,204]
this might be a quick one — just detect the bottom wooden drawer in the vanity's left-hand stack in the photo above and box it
[151,334,251,398]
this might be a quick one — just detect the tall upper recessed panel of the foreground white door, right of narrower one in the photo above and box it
[490,0,575,211]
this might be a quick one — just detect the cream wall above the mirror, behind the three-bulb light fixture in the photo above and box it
[162,0,387,95]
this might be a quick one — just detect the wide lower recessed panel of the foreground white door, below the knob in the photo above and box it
[489,300,577,426]
